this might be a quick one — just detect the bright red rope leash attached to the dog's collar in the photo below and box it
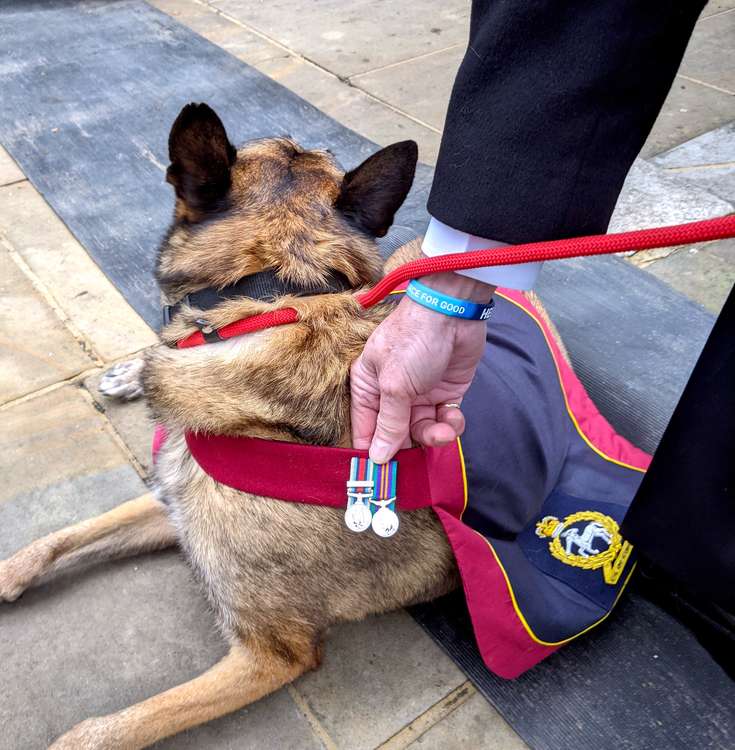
[178,214,735,349]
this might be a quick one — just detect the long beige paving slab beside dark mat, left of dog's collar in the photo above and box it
[0,185,157,368]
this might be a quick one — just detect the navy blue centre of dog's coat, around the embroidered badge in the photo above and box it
[462,298,642,643]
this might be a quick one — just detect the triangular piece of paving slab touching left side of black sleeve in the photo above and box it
[350,44,465,130]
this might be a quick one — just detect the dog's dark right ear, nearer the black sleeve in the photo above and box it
[336,141,419,237]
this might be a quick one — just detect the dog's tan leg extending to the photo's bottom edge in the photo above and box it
[50,644,317,750]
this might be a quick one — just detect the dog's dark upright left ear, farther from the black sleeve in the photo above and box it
[166,104,237,211]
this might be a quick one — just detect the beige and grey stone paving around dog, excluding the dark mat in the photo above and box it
[0,0,735,750]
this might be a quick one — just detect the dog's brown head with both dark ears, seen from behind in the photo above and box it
[157,104,417,301]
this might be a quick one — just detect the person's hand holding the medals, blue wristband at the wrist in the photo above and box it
[350,273,495,463]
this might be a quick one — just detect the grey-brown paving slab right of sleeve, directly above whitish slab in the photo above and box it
[641,76,735,158]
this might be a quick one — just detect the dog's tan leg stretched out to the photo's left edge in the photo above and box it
[0,493,177,602]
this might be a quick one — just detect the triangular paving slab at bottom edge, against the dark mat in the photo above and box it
[409,693,527,750]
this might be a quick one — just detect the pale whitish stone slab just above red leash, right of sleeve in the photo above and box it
[610,159,733,232]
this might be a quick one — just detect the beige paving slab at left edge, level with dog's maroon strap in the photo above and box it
[0,385,127,503]
